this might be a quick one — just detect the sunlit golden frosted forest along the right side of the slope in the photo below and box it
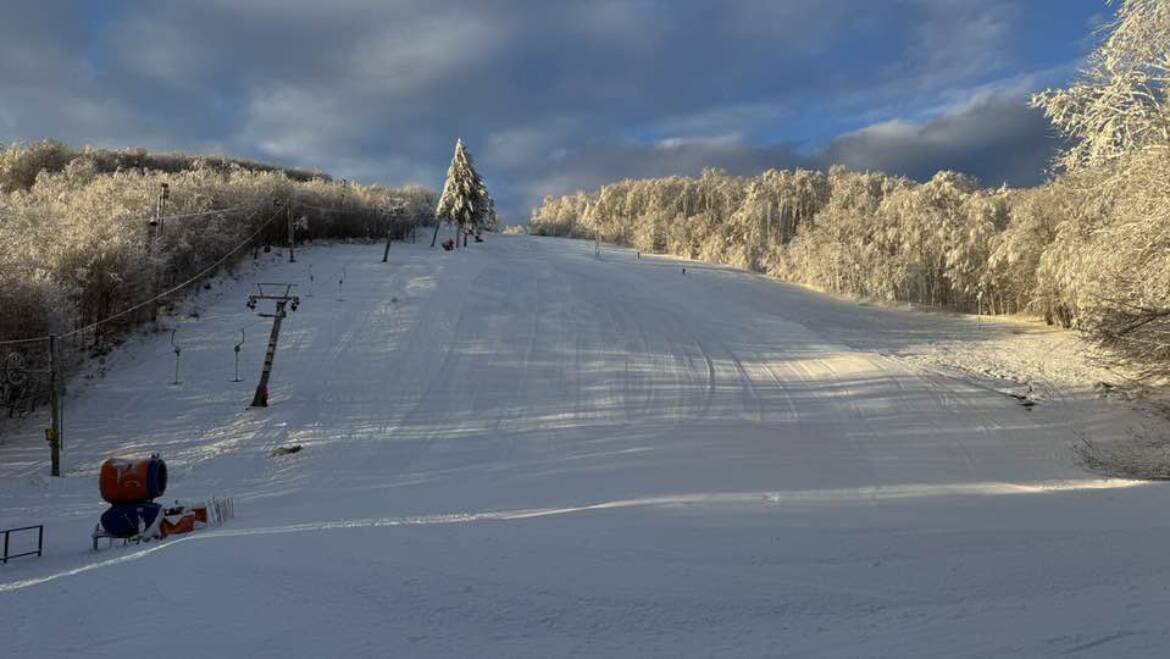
[531,0,1170,377]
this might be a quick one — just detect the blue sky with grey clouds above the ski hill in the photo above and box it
[0,0,1110,222]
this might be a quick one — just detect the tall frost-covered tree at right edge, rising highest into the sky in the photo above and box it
[1033,0,1170,376]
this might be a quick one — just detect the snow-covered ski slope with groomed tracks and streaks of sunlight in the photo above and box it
[0,236,1170,657]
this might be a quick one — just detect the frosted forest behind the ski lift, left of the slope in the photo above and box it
[0,140,436,413]
